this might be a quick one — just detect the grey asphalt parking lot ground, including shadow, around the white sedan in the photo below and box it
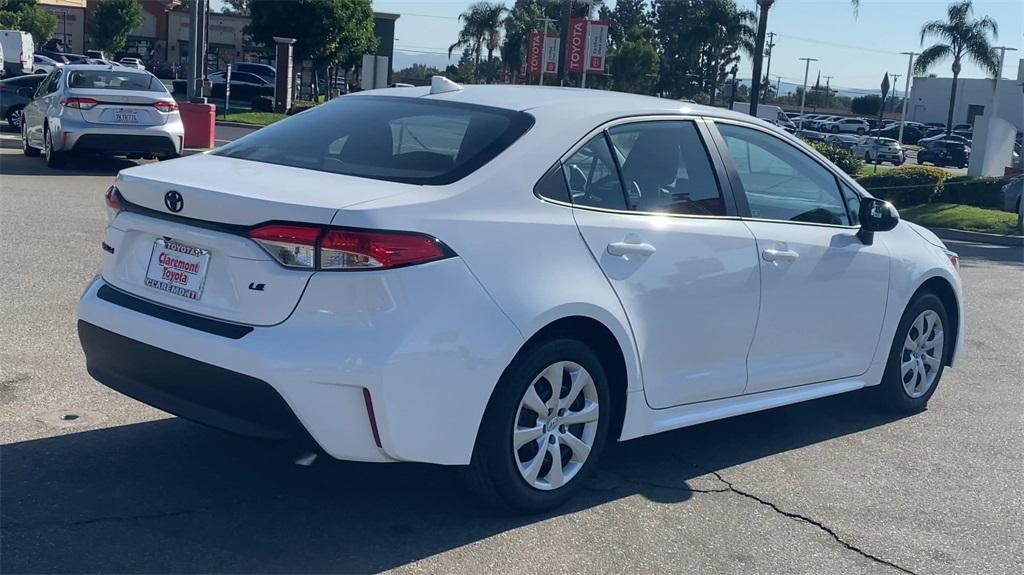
[0,134,1024,574]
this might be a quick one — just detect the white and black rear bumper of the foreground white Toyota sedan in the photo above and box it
[79,258,522,465]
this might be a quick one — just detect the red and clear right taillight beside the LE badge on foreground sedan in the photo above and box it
[249,224,450,270]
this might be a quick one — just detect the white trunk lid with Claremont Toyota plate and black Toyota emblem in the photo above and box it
[103,154,406,325]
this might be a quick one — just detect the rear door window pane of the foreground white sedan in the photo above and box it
[608,121,725,216]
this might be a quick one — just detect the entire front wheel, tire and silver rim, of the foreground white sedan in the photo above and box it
[880,293,951,413]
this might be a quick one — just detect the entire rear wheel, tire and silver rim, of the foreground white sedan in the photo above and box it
[466,339,611,512]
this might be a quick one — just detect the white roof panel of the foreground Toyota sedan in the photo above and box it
[346,84,758,122]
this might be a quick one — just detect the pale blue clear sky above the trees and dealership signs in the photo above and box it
[373,0,1024,91]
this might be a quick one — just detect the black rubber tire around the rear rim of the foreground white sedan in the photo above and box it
[463,337,612,513]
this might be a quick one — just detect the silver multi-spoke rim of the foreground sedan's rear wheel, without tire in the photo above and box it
[512,361,600,491]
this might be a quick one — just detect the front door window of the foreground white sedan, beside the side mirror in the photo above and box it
[717,123,851,225]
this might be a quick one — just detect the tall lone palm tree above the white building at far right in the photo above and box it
[913,0,1000,135]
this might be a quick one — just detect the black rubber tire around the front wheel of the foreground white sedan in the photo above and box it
[877,292,955,413]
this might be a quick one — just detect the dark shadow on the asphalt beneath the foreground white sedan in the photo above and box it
[0,386,909,573]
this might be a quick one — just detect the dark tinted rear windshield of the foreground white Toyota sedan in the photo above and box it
[212,96,534,185]
